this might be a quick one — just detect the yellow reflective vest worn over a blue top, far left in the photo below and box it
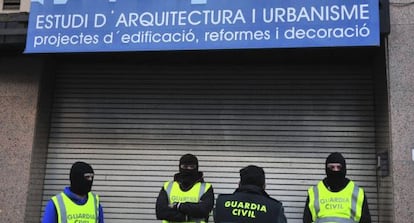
[52,192,99,223]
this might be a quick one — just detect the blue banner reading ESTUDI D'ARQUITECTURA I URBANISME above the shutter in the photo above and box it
[25,0,380,53]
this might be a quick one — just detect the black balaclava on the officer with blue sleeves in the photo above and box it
[70,162,94,196]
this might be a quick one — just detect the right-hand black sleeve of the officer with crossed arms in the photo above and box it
[178,186,214,218]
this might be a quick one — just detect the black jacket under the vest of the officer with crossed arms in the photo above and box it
[155,172,214,222]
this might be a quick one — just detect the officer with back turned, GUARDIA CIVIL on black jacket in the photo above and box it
[214,165,286,223]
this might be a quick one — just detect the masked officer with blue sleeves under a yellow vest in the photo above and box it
[42,162,104,223]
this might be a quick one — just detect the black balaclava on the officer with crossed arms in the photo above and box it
[178,154,202,190]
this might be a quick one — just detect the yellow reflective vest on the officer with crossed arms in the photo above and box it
[162,181,211,223]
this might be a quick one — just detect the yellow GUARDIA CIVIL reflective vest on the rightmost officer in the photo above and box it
[308,181,364,223]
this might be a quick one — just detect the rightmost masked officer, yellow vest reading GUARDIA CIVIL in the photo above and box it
[303,153,371,223]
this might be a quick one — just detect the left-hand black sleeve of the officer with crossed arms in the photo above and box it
[155,188,186,222]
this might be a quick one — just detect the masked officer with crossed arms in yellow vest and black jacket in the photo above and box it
[155,154,214,223]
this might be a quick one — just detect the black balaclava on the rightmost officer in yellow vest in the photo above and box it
[325,152,347,191]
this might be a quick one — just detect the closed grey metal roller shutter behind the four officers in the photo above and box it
[43,61,378,223]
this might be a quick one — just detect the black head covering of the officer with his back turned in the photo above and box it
[240,165,265,188]
